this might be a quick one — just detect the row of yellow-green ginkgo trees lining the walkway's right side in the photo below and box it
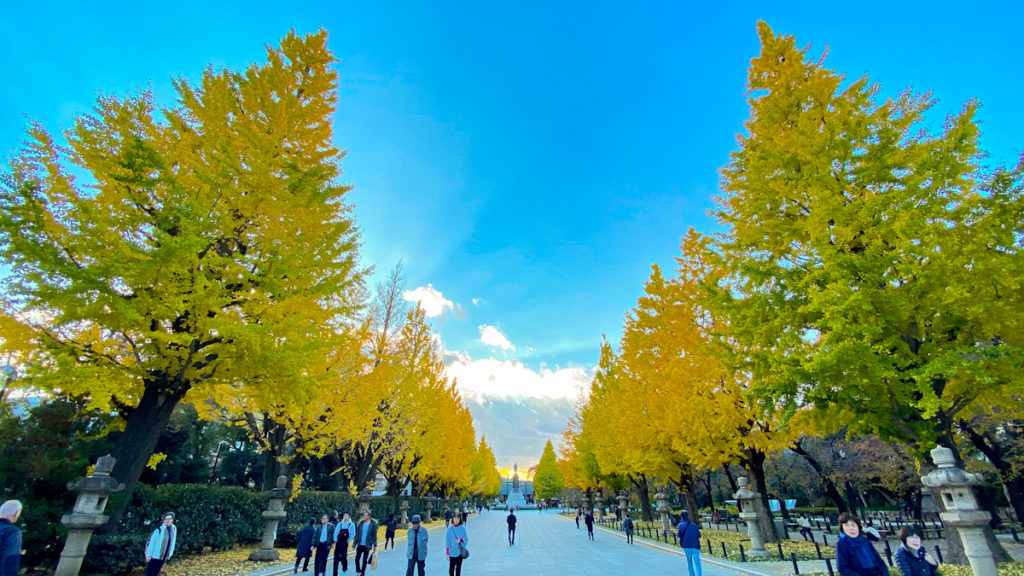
[562,23,1024,535]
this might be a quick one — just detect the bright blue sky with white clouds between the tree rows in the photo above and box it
[0,0,1024,465]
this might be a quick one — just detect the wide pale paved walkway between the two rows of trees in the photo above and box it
[245,510,764,576]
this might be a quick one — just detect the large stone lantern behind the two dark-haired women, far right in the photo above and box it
[921,446,995,576]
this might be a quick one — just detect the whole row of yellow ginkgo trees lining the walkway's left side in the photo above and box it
[0,31,500,518]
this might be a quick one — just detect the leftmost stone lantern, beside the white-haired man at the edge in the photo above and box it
[54,454,125,576]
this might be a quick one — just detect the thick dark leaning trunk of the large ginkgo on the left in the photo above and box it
[103,380,189,534]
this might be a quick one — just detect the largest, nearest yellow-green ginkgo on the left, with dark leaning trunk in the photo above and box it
[0,32,364,520]
